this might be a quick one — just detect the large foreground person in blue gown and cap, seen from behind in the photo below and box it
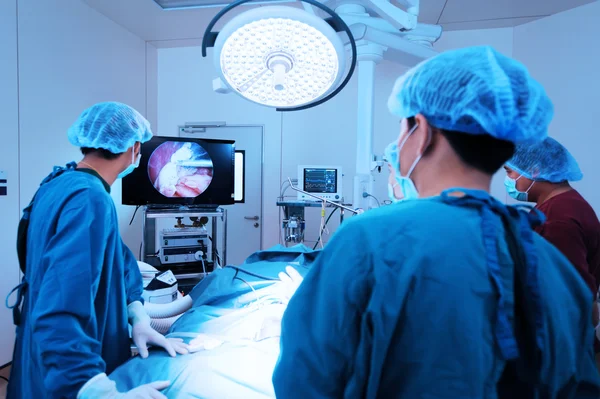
[273,47,600,399]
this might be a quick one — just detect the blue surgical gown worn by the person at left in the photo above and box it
[8,170,143,399]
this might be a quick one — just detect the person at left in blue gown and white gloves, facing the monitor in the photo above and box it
[8,102,185,399]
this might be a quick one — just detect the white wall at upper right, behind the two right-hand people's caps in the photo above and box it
[514,1,600,214]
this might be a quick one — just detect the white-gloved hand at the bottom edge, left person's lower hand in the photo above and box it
[77,373,171,399]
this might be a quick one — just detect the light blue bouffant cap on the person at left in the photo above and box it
[67,102,152,154]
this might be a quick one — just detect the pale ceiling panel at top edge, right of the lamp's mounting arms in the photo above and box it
[440,0,596,24]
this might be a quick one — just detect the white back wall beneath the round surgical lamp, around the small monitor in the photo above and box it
[157,29,513,248]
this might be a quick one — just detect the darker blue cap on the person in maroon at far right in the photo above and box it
[506,137,583,183]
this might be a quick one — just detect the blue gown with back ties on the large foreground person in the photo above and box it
[273,190,600,399]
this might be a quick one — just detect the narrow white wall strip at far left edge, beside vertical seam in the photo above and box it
[0,0,19,367]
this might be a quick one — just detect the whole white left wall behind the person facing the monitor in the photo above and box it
[0,0,152,365]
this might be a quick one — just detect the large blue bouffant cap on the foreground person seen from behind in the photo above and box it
[388,46,554,143]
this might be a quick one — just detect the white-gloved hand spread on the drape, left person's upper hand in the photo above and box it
[127,301,188,359]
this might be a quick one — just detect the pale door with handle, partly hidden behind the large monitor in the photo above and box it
[179,123,263,265]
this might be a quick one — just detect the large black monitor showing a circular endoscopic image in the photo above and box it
[122,137,235,207]
